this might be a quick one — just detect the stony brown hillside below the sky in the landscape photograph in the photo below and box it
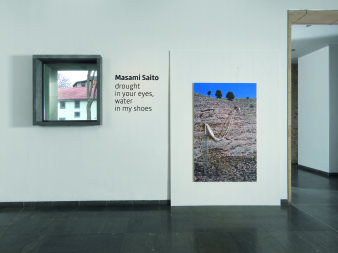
[194,93,257,182]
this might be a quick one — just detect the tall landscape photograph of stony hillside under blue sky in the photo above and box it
[193,83,257,182]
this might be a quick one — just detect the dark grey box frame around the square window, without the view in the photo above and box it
[33,55,102,126]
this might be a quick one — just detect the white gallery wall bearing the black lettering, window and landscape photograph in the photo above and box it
[0,0,338,205]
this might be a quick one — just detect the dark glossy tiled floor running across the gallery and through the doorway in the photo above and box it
[0,170,338,253]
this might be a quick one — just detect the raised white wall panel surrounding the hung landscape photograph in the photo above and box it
[170,50,285,205]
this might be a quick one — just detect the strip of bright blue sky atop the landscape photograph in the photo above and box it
[194,83,256,99]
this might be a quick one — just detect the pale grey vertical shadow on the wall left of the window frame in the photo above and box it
[9,55,33,127]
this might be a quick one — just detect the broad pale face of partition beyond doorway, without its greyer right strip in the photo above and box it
[298,46,330,172]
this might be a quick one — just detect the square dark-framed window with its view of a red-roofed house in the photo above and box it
[33,55,102,126]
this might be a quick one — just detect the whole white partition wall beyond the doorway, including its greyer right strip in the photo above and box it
[298,45,338,173]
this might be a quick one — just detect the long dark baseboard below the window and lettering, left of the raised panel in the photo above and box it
[0,200,170,208]
